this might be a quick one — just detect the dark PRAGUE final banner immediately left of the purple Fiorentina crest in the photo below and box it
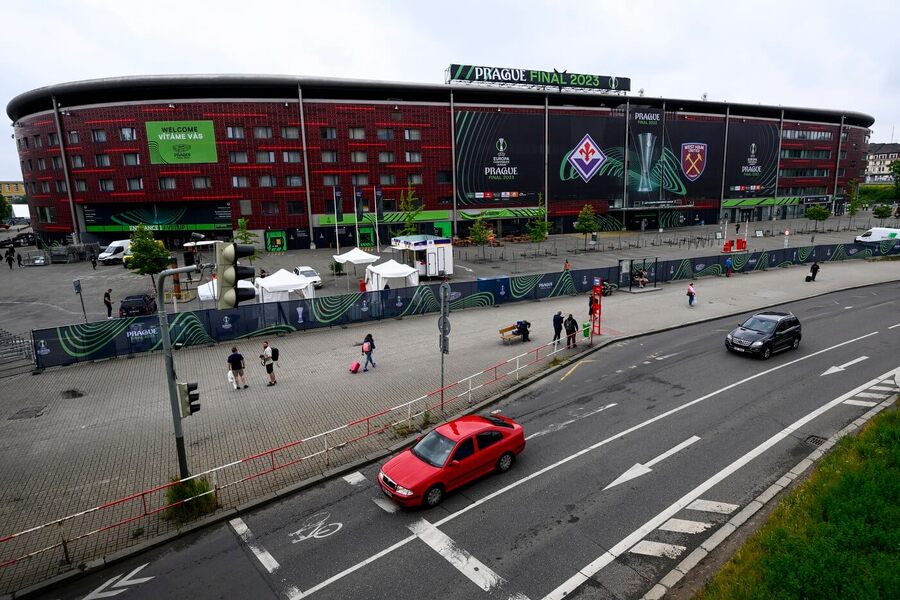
[455,110,544,205]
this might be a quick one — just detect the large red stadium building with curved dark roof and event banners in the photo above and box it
[7,74,874,250]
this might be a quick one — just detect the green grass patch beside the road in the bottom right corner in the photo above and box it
[695,404,900,600]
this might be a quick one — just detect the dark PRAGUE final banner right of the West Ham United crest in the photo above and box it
[725,117,779,198]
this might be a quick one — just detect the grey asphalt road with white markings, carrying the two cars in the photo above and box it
[22,283,900,600]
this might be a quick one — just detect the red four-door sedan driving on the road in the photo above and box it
[378,414,525,508]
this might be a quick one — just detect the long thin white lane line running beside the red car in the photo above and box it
[304,331,884,596]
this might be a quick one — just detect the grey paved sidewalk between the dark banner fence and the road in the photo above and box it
[0,261,900,593]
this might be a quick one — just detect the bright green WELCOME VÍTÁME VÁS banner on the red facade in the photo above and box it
[146,121,218,165]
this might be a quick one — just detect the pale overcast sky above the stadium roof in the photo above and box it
[0,0,900,180]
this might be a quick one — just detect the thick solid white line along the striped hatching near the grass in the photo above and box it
[536,366,900,600]
